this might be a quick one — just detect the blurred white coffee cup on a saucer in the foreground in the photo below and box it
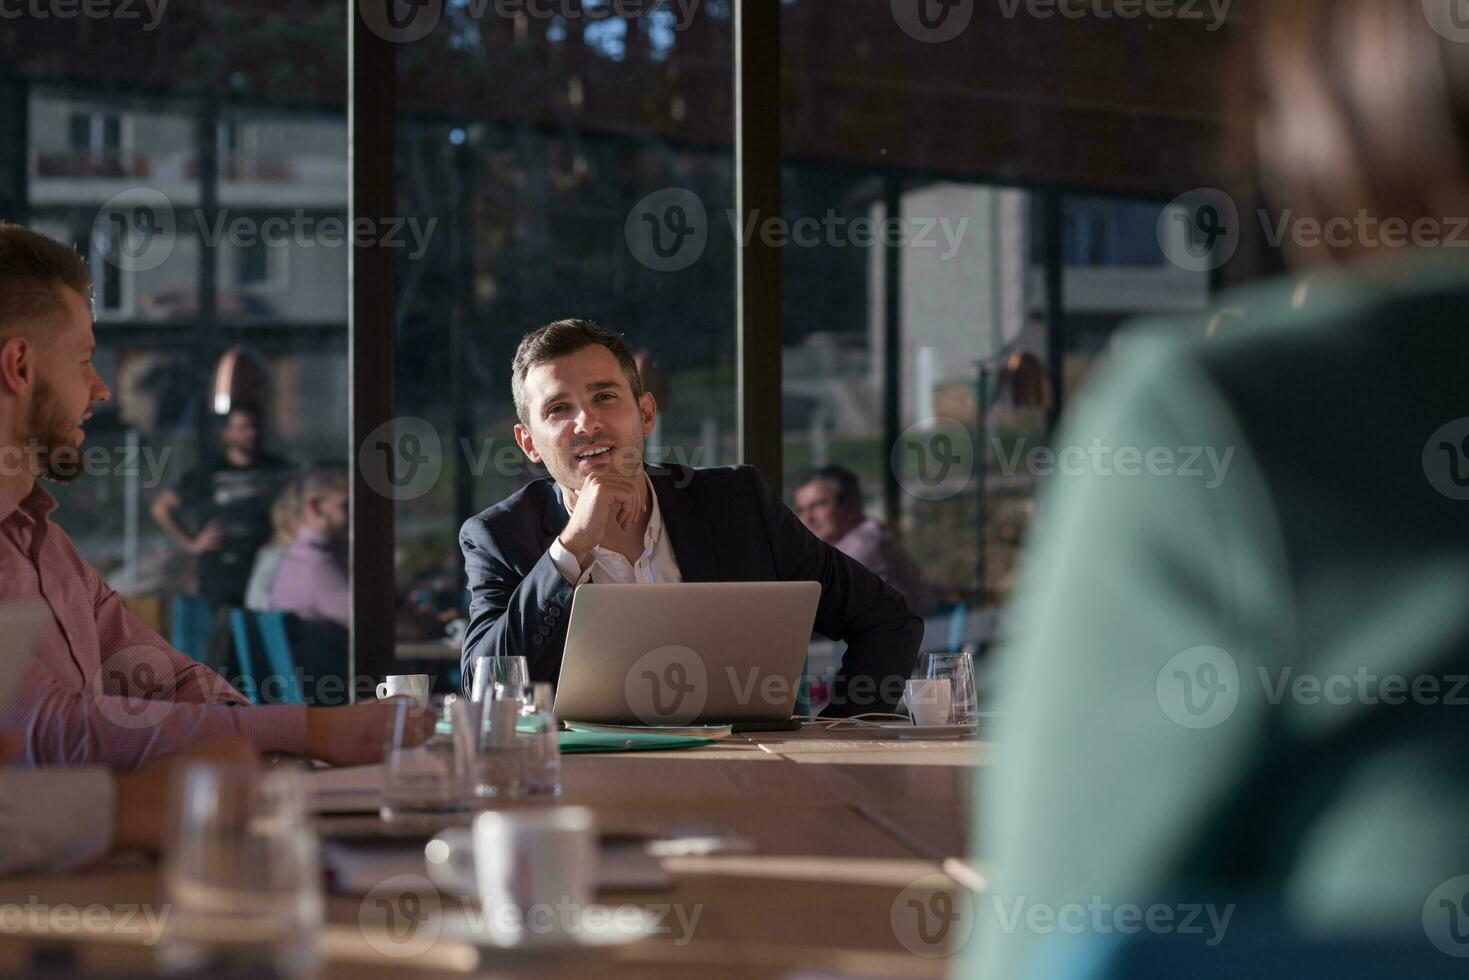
[425,807,598,946]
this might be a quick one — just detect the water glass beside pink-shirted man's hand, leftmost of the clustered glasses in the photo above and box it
[382,695,477,821]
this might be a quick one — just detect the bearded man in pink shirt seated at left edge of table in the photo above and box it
[0,222,408,770]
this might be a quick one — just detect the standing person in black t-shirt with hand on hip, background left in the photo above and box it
[153,406,291,607]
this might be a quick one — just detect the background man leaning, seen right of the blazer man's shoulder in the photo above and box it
[793,466,937,616]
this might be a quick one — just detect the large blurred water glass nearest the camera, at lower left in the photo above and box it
[159,763,323,977]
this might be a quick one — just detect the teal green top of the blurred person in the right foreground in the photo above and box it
[962,264,1469,980]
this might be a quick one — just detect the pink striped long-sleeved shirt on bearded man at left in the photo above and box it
[0,485,306,768]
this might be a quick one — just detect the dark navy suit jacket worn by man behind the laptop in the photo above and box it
[460,466,923,716]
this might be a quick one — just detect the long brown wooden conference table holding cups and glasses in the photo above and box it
[0,726,989,980]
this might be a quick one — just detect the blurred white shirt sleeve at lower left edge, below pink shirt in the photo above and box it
[0,767,115,874]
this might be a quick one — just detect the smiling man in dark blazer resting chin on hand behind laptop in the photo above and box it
[460,320,923,717]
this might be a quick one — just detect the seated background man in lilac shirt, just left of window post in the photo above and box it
[267,463,353,629]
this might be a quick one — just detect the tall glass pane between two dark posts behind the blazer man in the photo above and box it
[397,3,737,664]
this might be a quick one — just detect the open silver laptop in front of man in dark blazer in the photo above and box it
[555,582,821,726]
